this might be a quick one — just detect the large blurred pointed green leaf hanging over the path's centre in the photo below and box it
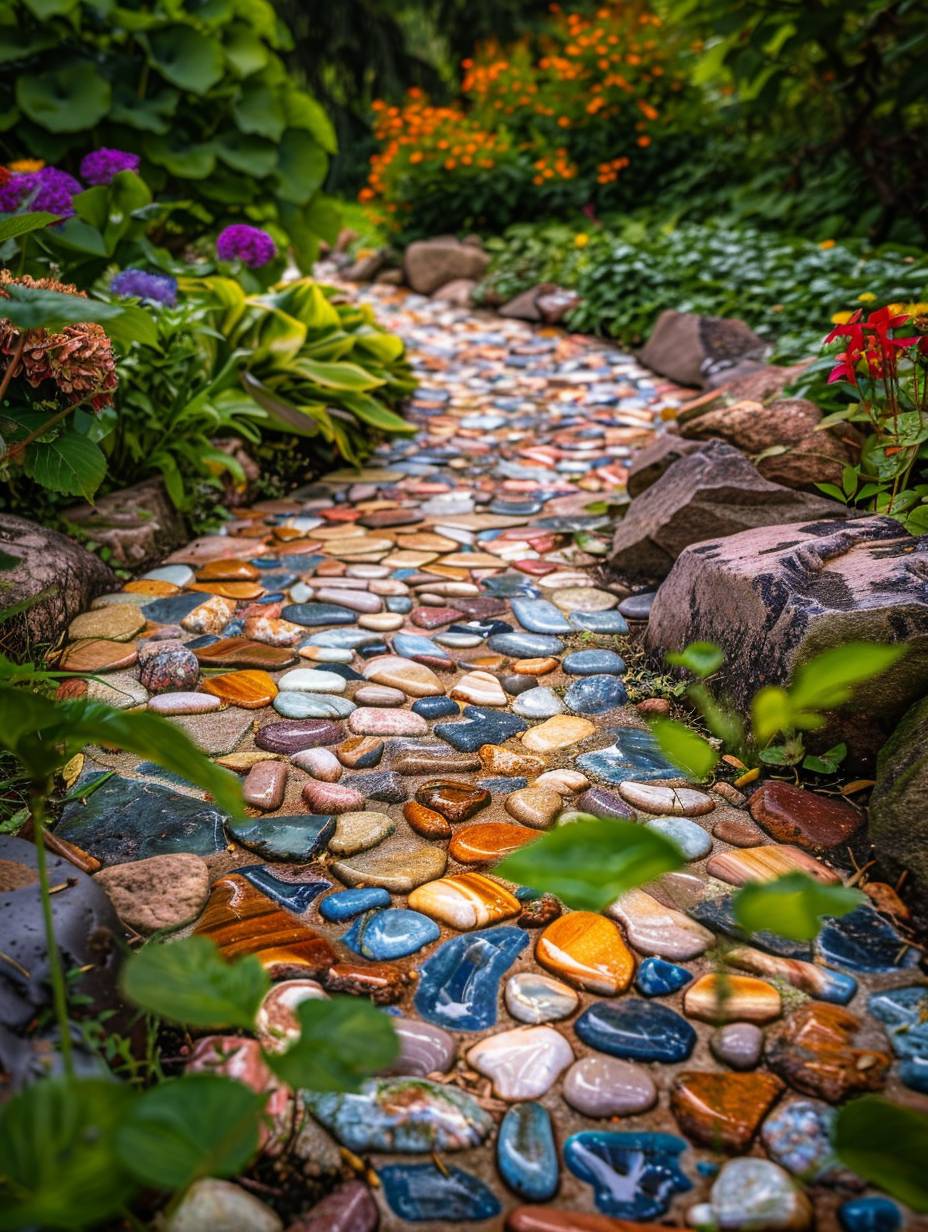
[493,819,685,912]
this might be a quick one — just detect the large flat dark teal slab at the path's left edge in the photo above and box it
[55,772,226,865]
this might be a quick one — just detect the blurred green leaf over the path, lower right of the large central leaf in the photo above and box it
[732,872,868,941]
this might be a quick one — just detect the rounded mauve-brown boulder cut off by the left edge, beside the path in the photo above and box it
[0,514,116,659]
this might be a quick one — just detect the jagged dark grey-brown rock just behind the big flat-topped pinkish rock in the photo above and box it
[610,441,848,579]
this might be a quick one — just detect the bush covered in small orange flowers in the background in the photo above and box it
[361,0,683,237]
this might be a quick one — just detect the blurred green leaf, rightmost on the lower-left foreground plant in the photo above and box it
[265,997,399,1092]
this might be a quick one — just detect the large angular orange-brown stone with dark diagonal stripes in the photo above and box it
[193,873,335,975]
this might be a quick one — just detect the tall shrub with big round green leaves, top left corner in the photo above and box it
[0,0,338,264]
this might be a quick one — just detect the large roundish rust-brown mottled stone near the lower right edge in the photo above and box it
[767,1002,892,1104]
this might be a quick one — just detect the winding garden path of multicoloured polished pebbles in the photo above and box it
[57,288,928,1232]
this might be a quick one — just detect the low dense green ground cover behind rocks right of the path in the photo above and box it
[473,217,928,362]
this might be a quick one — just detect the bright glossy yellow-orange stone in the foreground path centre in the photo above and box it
[535,912,635,997]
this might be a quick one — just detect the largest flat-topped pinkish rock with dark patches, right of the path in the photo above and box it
[647,512,928,758]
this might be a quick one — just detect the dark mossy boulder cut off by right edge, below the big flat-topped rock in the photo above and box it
[870,697,928,903]
